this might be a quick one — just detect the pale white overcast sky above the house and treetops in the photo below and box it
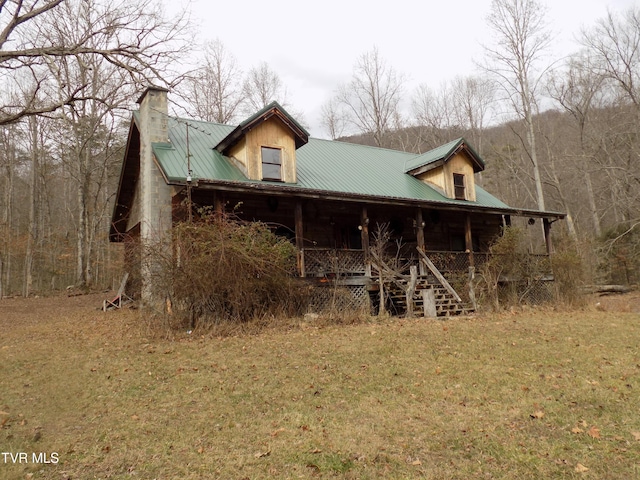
[178,0,637,137]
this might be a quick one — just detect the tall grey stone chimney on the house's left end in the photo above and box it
[138,87,171,303]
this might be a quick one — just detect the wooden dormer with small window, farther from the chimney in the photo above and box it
[404,138,484,202]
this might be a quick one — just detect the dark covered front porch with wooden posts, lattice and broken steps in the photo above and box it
[180,186,552,316]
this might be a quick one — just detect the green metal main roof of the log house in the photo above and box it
[148,114,556,213]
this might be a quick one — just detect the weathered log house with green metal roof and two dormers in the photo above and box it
[110,87,564,312]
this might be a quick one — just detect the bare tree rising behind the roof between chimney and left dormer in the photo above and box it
[178,40,245,123]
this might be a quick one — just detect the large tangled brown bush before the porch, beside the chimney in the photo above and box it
[149,213,305,327]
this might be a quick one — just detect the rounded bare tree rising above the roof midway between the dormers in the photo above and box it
[336,48,404,146]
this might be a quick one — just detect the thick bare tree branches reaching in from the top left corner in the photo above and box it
[0,0,188,125]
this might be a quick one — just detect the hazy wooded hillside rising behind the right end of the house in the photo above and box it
[340,101,640,241]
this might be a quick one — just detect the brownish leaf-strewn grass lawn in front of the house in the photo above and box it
[0,295,640,479]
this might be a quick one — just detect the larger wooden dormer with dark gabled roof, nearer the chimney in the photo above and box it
[215,102,309,183]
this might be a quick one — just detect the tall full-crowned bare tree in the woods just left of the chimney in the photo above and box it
[36,0,152,287]
